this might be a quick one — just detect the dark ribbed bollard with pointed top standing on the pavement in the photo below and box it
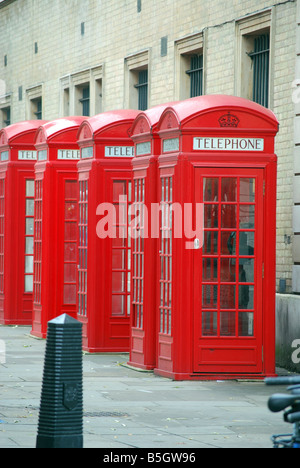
[36,314,83,448]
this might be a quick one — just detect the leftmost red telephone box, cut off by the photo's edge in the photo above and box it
[0,120,45,325]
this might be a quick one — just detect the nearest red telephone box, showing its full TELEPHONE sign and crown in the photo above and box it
[155,96,278,380]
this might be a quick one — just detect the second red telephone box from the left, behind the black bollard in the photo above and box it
[31,117,85,338]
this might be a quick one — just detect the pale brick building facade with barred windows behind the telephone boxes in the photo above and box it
[0,0,300,368]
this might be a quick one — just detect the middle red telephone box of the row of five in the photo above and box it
[77,110,138,352]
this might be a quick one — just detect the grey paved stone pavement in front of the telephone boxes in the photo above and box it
[0,325,291,451]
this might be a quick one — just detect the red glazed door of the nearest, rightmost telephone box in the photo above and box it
[194,168,264,374]
